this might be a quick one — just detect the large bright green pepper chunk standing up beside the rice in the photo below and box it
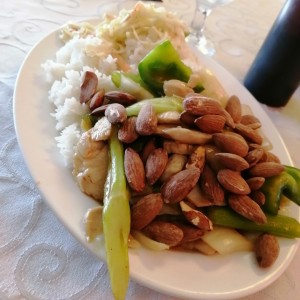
[138,40,192,95]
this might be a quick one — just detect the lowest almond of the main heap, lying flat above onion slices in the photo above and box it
[143,220,183,247]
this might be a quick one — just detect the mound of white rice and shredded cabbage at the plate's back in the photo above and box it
[42,3,218,167]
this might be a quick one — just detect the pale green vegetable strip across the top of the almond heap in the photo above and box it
[126,96,183,117]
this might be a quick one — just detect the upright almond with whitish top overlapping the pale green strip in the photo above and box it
[136,103,157,135]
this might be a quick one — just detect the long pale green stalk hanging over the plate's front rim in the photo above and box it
[103,127,130,300]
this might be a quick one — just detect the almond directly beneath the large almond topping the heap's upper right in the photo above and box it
[195,115,226,133]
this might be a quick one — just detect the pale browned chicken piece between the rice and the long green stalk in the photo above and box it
[73,130,108,202]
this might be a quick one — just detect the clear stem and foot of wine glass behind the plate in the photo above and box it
[188,0,233,56]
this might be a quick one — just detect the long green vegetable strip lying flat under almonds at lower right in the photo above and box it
[207,207,300,238]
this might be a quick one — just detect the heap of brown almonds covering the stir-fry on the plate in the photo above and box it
[82,72,284,266]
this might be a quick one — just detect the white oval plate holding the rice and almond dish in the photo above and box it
[14,19,299,299]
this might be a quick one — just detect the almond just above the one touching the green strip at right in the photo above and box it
[217,169,251,195]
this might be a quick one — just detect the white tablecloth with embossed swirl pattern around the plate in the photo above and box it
[0,0,300,300]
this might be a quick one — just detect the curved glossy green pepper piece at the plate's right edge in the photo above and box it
[260,166,300,215]
